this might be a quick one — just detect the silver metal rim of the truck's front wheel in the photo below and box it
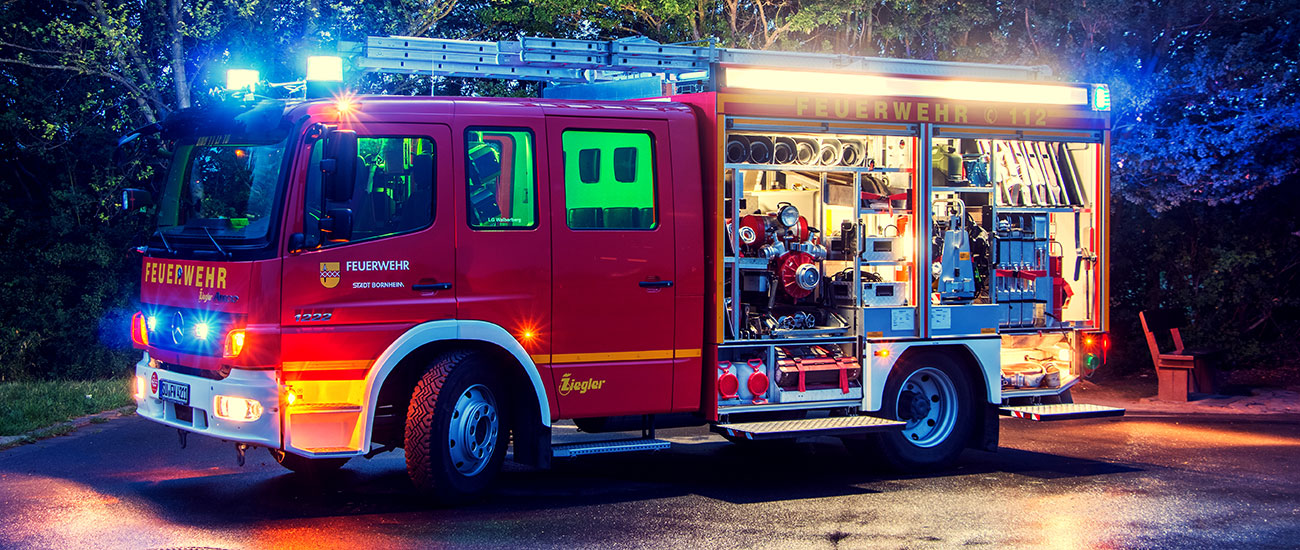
[447,384,501,477]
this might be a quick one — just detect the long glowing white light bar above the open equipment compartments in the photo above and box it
[723,68,1089,105]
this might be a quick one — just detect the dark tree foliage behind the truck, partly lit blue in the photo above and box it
[0,0,1300,380]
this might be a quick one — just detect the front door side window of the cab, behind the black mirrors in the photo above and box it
[303,137,437,247]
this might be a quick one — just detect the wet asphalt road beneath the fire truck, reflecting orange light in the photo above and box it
[0,416,1300,549]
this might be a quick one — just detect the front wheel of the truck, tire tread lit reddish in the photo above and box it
[404,351,510,501]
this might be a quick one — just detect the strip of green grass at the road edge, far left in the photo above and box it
[0,378,134,436]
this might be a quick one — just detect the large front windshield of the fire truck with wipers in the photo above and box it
[159,138,285,243]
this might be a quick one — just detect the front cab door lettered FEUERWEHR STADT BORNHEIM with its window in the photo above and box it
[281,124,456,382]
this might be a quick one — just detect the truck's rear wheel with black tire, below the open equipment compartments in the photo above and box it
[844,352,976,472]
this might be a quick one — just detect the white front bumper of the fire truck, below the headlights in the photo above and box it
[135,352,282,449]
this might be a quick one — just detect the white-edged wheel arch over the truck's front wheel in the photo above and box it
[363,320,551,449]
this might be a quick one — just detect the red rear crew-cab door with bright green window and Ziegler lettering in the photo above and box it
[546,117,676,417]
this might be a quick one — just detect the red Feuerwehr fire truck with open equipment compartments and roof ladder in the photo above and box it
[124,38,1123,495]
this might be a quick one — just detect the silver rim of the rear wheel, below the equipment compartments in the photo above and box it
[896,367,958,447]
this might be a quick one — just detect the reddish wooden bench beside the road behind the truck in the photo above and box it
[1138,309,1219,402]
